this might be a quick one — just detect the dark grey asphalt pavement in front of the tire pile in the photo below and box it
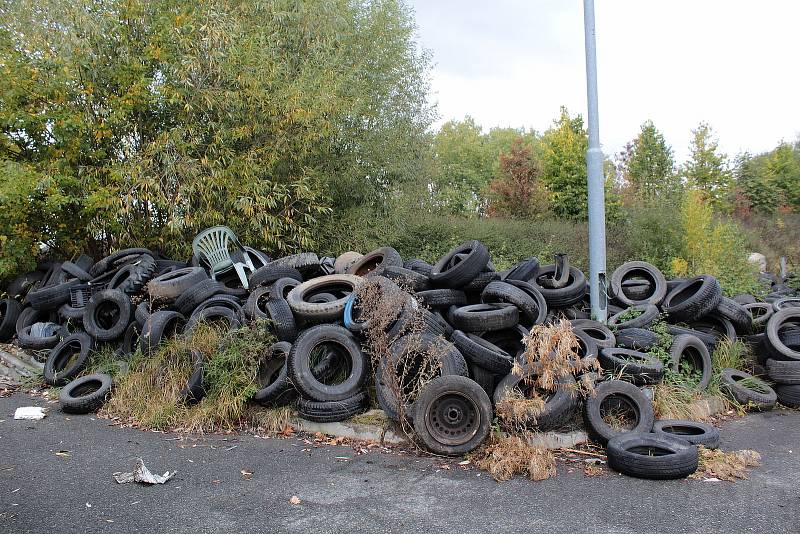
[0,394,800,533]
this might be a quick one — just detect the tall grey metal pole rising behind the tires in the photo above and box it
[583,0,608,323]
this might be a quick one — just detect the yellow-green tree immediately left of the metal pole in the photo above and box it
[541,107,589,219]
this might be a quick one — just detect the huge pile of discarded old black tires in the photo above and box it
[0,241,800,478]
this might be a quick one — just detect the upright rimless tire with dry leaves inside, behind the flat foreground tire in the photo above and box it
[583,380,655,444]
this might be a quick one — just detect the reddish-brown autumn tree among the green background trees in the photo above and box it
[489,137,548,222]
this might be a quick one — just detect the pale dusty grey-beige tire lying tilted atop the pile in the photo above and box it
[286,274,363,323]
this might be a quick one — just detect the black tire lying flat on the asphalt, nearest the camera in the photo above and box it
[606,433,698,480]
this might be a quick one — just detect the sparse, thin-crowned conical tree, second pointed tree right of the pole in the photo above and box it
[683,122,732,210]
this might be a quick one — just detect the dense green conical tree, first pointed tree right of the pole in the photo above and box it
[622,121,680,200]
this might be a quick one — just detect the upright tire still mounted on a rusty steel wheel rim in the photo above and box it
[414,375,492,456]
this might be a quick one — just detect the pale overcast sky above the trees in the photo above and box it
[407,0,800,161]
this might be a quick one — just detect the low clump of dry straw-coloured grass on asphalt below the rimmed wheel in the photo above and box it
[469,436,556,482]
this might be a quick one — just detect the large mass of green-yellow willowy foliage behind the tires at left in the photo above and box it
[0,0,432,276]
